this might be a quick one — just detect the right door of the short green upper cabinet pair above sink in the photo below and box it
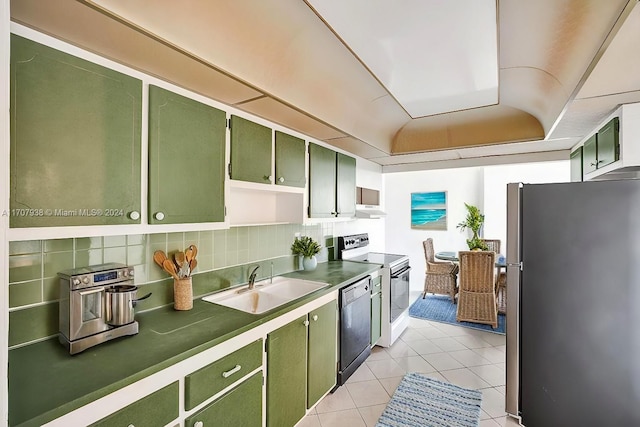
[275,131,306,188]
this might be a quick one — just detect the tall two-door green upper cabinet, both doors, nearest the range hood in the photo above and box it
[309,144,356,218]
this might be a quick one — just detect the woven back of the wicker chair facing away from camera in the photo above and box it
[458,251,496,293]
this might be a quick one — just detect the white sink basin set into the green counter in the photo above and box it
[202,276,327,314]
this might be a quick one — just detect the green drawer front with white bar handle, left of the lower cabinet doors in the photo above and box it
[184,339,263,411]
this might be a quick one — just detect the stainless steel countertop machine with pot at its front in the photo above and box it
[58,263,151,354]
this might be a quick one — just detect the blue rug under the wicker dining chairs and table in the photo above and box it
[409,294,507,335]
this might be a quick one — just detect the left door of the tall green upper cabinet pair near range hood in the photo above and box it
[309,143,338,218]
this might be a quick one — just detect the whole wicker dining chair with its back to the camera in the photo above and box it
[456,251,498,328]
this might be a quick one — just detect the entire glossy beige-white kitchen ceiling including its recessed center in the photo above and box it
[11,0,640,172]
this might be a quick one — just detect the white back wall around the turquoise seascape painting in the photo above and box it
[383,160,570,290]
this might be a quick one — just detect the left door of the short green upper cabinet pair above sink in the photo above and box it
[229,116,273,184]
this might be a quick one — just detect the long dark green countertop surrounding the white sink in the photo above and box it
[9,261,379,426]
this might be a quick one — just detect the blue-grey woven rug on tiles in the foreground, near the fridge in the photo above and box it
[376,373,482,427]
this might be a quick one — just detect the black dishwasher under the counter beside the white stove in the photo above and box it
[338,276,371,385]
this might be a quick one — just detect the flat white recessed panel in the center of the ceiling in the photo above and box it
[307,0,498,118]
